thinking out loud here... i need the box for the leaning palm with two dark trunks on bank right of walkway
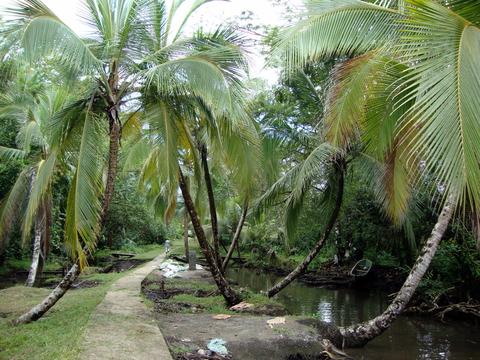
[131,92,255,305]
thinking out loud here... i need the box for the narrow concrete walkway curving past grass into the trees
[79,256,172,360]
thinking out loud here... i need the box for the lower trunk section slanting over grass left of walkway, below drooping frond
[14,264,80,325]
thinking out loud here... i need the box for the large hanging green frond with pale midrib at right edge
[400,0,480,212]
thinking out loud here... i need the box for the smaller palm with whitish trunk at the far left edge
[0,71,55,286]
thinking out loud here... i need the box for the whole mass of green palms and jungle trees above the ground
[0,0,480,358]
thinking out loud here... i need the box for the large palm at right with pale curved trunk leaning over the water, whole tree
[280,0,480,346]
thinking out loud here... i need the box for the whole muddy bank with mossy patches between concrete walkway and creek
[142,270,344,360]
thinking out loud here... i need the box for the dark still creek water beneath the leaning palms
[228,269,480,360]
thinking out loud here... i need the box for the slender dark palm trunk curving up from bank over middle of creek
[267,164,345,297]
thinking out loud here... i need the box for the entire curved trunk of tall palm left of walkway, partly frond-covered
[14,110,120,324]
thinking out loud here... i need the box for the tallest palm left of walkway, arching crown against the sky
[9,0,251,319]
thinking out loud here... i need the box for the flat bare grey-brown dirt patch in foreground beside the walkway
[156,314,323,360]
